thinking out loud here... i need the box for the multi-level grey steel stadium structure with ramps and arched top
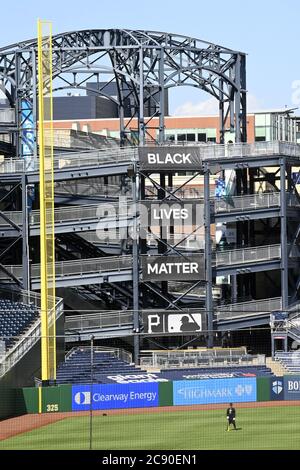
[0,30,300,361]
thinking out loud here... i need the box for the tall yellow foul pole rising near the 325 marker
[38,20,56,382]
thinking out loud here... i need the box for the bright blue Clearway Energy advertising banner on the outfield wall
[72,383,159,411]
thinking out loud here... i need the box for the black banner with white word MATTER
[141,254,205,281]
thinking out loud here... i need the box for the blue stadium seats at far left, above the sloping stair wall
[0,299,39,349]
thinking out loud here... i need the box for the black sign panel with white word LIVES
[139,199,204,227]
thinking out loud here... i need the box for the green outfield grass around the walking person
[0,406,300,450]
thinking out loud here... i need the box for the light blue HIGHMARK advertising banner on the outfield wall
[173,378,256,405]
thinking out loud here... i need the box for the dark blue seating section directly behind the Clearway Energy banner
[56,348,146,384]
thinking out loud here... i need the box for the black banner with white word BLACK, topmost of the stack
[139,146,203,172]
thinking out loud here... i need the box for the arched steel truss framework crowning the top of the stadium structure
[0,29,246,156]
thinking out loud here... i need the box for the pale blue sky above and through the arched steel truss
[0,0,300,115]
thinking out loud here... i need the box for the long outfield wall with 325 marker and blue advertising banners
[0,375,300,417]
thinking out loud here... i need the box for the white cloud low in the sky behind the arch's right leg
[174,93,263,116]
